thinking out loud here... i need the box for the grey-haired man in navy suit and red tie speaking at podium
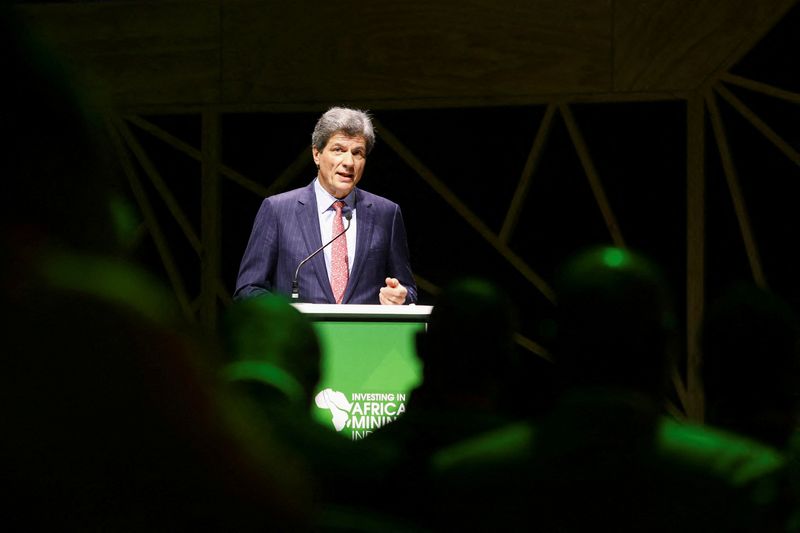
[234,107,417,305]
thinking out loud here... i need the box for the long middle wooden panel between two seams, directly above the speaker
[223,0,611,105]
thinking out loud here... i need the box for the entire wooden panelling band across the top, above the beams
[15,0,795,110]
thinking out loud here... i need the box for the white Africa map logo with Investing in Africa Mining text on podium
[314,389,406,440]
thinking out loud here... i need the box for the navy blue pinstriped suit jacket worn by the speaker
[234,181,417,304]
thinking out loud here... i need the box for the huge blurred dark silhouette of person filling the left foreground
[0,8,307,531]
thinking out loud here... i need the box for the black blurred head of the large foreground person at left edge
[0,6,125,258]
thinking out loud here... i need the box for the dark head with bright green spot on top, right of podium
[556,247,674,394]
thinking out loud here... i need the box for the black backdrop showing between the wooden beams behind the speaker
[128,3,800,354]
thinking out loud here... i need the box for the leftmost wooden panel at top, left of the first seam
[19,0,221,107]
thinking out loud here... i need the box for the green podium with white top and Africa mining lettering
[293,304,432,440]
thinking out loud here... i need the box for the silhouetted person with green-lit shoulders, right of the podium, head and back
[432,247,785,531]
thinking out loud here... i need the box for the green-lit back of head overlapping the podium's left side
[223,294,321,406]
